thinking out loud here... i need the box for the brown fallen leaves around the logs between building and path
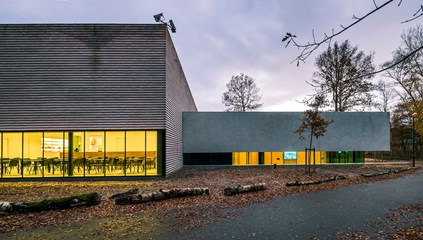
[0,165,420,238]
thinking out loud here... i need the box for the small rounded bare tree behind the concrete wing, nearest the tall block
[222,73,263,112]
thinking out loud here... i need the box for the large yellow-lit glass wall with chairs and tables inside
[0,131,162,178]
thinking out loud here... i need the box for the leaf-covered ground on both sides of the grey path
[0,164,423,239]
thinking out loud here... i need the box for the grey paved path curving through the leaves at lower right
[168,173,423,239]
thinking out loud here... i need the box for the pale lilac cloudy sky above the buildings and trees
[0,0,423,111]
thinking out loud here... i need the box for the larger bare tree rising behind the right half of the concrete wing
[310,40,374,112]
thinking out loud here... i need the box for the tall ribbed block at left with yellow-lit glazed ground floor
[0,24,197,178]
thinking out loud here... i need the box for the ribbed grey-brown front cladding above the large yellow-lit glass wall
[0,24,168,131]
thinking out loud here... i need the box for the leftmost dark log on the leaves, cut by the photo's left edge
[0,192,101,214]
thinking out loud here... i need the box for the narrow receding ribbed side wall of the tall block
[166,31,197,174]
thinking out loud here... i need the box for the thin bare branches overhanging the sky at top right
[282,0,423,75]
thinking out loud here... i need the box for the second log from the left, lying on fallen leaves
[114,188,210,205]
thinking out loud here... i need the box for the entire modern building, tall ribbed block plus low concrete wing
[0,24,390,178]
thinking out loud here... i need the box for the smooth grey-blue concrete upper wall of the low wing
[183,112,390,153]
